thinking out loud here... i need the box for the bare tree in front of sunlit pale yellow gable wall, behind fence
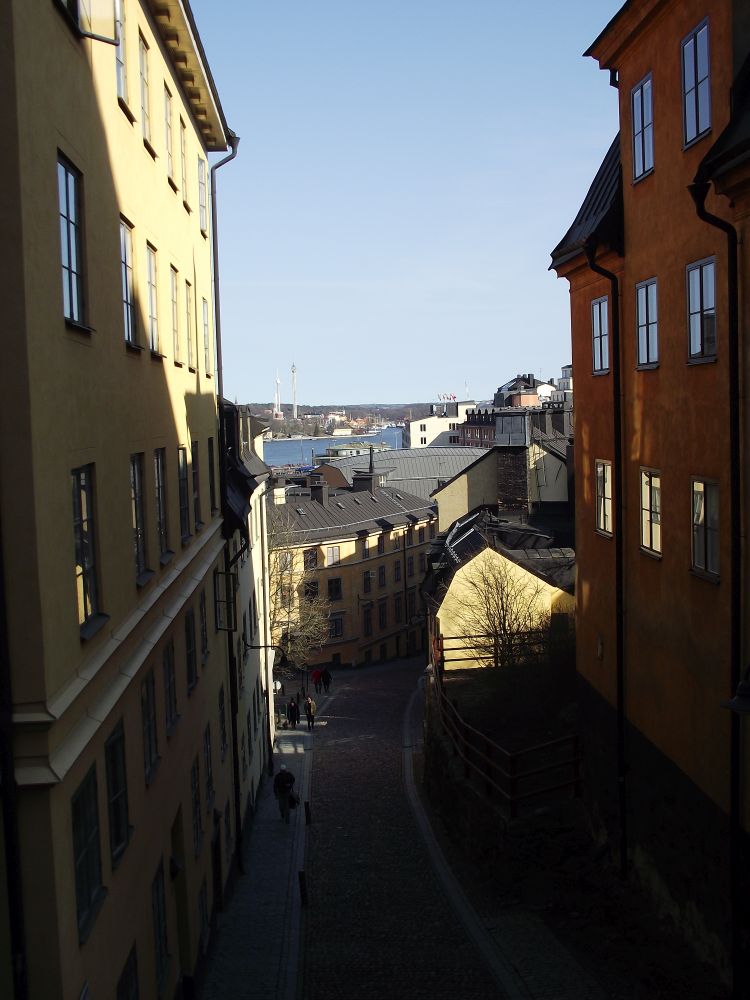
[446,549,550,666]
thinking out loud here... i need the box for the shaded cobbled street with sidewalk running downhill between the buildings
[200,659,608,1000]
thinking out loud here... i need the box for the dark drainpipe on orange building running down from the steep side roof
[584,240,628,879]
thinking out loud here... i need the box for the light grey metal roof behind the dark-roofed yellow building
[320,445,486,500]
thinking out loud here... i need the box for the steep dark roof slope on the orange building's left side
[550,132,623,270]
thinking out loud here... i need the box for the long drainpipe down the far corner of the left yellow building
[210,129,245,874]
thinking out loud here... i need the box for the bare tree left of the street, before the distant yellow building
[268,504,331,675]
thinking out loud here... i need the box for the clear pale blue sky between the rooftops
[191,0,621,404]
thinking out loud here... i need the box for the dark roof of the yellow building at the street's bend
[273,486,437,544]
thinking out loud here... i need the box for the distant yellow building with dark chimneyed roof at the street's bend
[272,469,437,666]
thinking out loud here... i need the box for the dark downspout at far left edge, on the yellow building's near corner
[0,531,29,1000]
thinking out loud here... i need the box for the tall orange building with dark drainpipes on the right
[552,0,750,984]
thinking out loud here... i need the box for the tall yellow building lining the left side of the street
[0,0,242,1000]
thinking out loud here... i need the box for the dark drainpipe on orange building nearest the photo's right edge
[688,181,746,998]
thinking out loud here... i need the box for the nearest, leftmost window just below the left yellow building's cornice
[71,765,104,940]
